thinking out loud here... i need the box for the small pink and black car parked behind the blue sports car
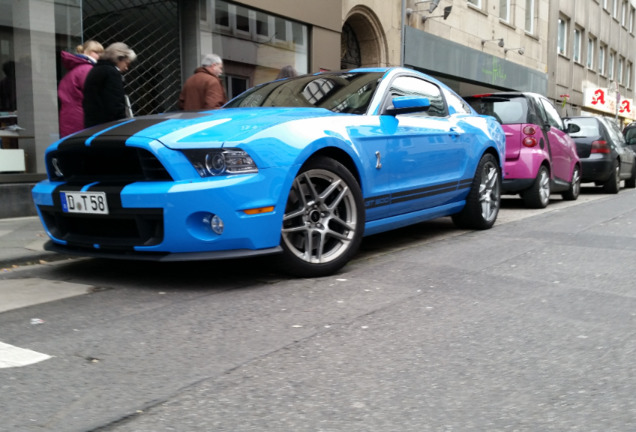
[464,92,581,208]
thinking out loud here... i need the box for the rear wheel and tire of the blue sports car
[452,154,501,230]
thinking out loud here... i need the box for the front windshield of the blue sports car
[224,72,383,114]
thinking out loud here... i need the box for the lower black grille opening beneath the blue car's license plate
[39,206,164,250]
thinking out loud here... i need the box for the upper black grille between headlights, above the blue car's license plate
[47,146,172,183]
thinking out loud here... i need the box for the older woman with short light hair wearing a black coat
[83,42,137,127]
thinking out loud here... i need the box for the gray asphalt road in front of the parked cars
[0,186,636,432]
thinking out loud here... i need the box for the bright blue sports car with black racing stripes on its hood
[33,68,505,277]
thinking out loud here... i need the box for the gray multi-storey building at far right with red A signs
[548,0,636,124]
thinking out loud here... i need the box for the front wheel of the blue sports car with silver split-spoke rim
[280,157,365,277]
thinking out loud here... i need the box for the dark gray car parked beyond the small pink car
[563,116,636,193]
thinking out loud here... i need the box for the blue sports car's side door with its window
[358,75,469,216]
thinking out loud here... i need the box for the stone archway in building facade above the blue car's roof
[340,6,388,69]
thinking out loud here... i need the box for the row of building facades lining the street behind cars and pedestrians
[0,0,636,217]
